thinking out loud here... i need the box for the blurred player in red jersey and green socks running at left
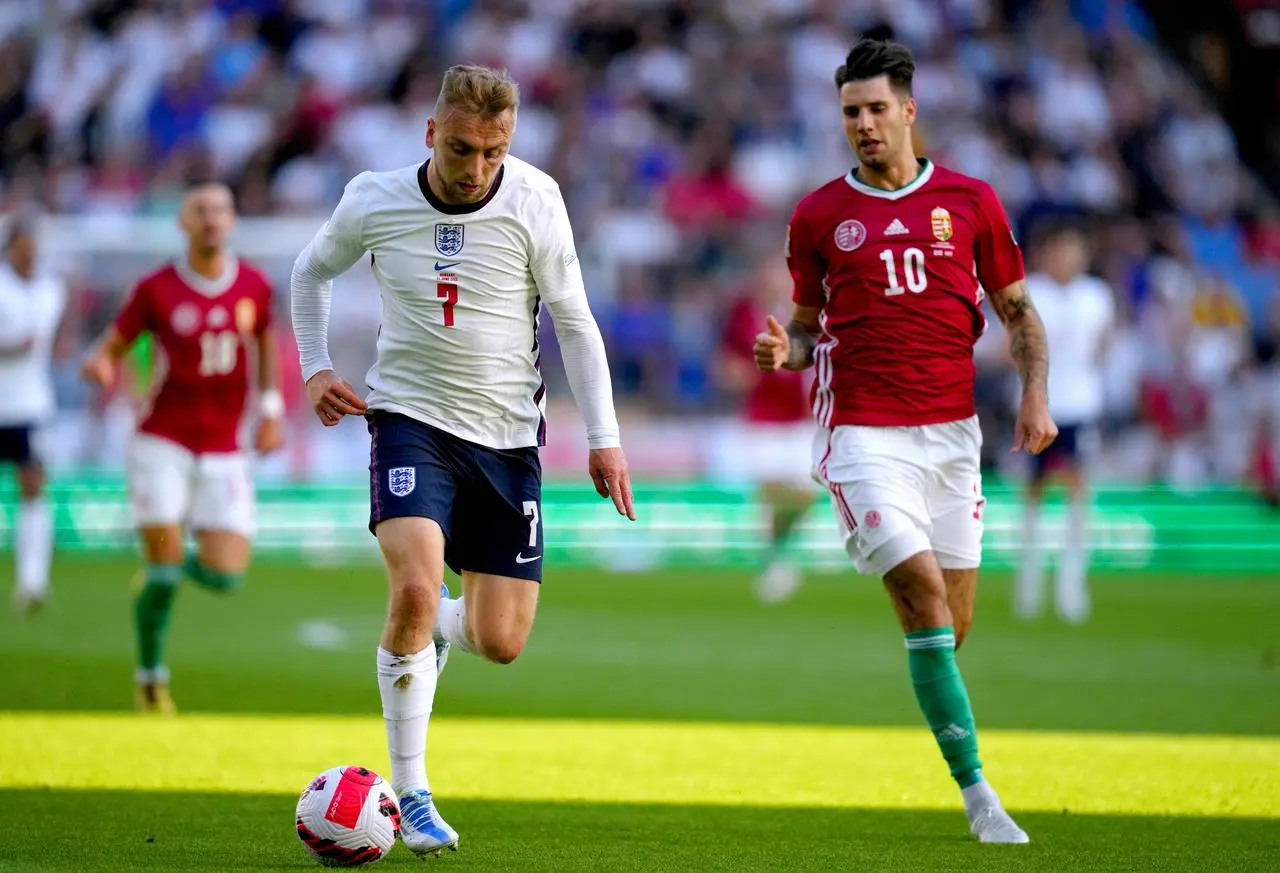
[83,182,284,712]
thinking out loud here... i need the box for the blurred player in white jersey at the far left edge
[0,220,67,613]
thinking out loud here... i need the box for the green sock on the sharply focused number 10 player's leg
[906,627,982,789]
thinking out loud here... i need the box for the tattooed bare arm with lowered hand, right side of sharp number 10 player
[991,279,1057,454]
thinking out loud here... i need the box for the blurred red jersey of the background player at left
[115,261,271,453]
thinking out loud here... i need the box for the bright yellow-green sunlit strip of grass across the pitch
[0,713,1280,818]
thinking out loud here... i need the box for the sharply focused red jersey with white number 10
[787,160,1024,428]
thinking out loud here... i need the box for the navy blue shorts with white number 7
[365,410,543,582]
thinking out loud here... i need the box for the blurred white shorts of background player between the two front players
[708,421,814,488]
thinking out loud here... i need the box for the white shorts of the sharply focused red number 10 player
[813,416,987,576]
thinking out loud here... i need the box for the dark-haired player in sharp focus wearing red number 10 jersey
[755,38,1057,842]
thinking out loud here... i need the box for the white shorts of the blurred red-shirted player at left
[128,434,255,536]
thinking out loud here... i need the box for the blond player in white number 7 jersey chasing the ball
[292,67,635,854]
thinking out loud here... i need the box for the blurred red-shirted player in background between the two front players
[710,257,815,603]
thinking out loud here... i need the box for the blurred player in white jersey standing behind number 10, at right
[1014,223,1115,623]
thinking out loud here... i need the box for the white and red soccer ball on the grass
[297,767,399,867]
